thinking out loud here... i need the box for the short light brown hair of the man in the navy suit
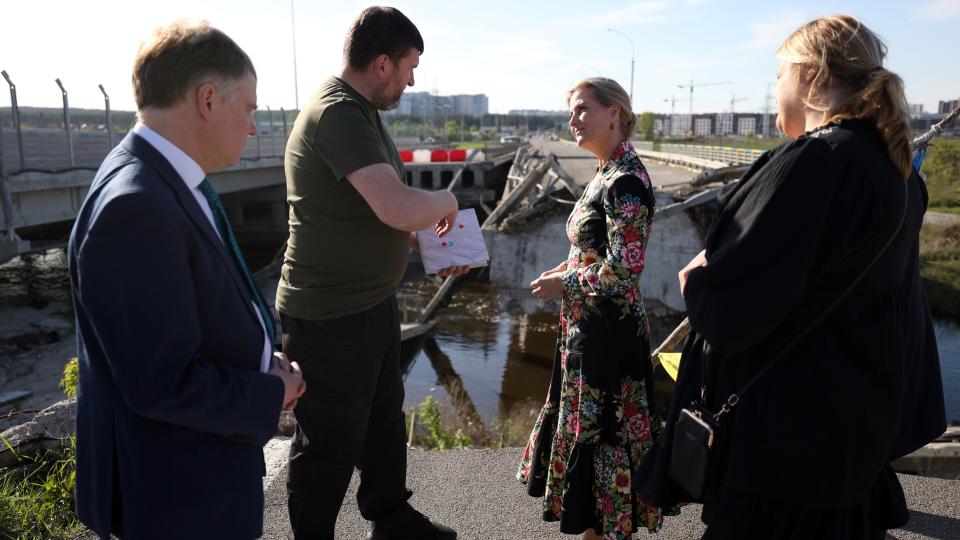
[133,19,257,110]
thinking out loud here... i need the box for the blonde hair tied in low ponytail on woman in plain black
[777,15,912,179]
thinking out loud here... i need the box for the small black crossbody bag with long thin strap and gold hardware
[669,178,910,503]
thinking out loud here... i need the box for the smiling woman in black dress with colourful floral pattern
[517,78,662,539]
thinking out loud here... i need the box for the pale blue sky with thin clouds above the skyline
[0,0,960,113]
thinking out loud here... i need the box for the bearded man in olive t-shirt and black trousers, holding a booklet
[277,7,467,540]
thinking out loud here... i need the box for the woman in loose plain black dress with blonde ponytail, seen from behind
[638,16,946,540]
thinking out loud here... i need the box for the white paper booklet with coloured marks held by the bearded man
[417,208,490,274]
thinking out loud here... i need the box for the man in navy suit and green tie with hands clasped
[68,21,304,539]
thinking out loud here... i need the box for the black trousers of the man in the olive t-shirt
[280,296,412,539]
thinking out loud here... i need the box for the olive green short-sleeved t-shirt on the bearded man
[277,77,409,320]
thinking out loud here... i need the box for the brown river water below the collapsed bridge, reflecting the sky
[401,283,960,438]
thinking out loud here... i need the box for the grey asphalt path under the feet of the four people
[263,441,960,540]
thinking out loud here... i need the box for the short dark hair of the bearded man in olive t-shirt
[343,6,423,69]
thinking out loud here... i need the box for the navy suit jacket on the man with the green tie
[68,133,283,539]
